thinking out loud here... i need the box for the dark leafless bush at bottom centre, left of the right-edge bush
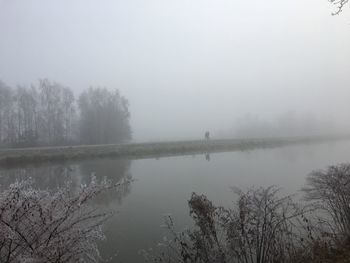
[144,187,307,263]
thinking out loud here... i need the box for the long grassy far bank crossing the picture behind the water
[0,135,350,165]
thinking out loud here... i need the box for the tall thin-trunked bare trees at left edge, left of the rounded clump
[0,79,75,147]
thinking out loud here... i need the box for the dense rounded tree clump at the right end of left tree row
[79,88,131,144]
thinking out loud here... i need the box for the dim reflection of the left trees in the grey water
[0,159,132,205]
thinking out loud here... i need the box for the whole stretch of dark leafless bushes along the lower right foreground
[143,164,350,263]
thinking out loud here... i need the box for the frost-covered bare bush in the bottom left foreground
[0,178,126,262]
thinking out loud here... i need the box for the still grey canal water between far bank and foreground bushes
[0,142,350,262]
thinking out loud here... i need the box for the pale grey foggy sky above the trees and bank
[0,0,350,140]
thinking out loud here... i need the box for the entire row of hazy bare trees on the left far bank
[0,79,131,147]
